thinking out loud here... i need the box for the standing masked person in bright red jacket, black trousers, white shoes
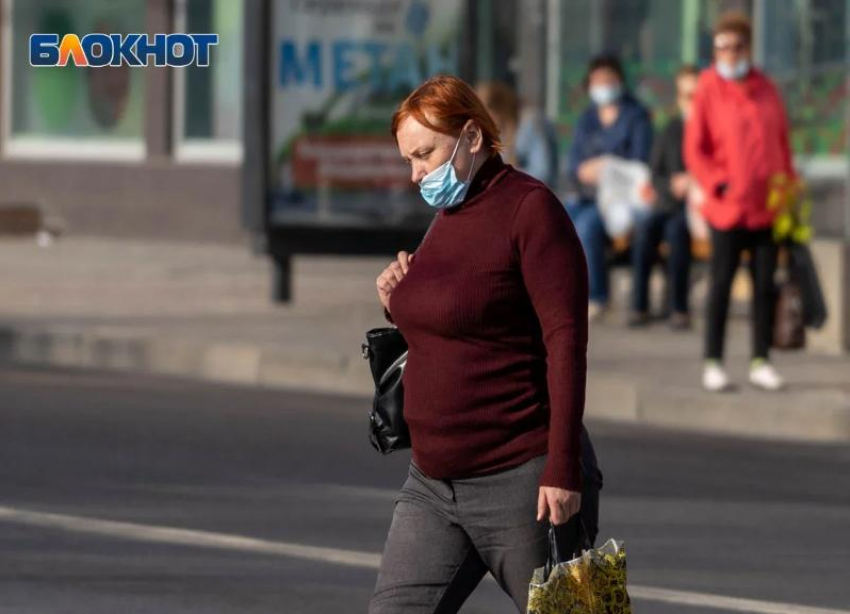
[684,14,794,392]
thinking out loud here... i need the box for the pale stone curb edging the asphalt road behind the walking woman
[0,326,850,443]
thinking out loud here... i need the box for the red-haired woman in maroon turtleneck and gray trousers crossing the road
[369,77,588,614]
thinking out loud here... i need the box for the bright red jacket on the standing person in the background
[684,67,794,230]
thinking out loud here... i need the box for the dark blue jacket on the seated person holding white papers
[567,93,652,201]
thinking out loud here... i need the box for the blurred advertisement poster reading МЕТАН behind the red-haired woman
[270,0,463,228]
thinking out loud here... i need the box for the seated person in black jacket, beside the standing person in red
[629,66,699,330]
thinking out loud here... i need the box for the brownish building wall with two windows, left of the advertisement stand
[0,0,244,242]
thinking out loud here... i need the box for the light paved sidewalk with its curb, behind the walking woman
[0,237,850,442]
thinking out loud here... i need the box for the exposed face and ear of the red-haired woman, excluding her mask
[396,116,482,184]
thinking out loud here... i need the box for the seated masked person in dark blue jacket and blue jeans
[567,54,652,320]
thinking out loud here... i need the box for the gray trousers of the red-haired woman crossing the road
[369,455,578,614]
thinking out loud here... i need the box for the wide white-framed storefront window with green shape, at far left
[4,0,147,158]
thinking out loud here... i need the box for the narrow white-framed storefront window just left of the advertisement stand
[176,0,244,162]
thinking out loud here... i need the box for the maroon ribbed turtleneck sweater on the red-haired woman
[390,156,588,490]
